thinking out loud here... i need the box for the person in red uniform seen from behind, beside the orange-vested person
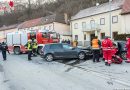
[102,36,113,66]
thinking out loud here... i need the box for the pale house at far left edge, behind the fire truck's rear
[0,24,18,42]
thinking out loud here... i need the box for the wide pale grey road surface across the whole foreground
[0,55,130,90]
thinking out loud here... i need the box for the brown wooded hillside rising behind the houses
[0,0,109,26]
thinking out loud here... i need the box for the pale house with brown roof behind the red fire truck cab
[41,14,72,41]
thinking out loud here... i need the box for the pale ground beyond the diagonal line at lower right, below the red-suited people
[73,61,130,86]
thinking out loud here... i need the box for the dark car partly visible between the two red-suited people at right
[114,41,127,60]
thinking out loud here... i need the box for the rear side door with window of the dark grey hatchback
[50,44,64,58]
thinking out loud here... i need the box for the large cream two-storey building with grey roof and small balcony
[71,0,130,46]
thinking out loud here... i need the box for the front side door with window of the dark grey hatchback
[63,44,77,58]
